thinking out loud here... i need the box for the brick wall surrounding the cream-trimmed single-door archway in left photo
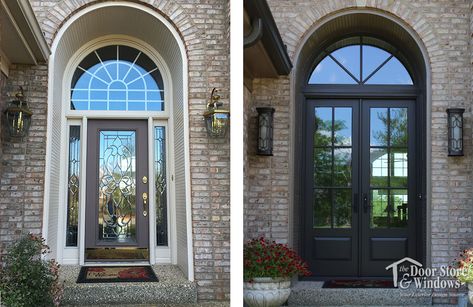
[0,0,230,300]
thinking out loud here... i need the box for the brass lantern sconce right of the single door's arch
[204,88,230,138]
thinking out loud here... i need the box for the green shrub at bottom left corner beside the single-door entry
[0,234,62,307]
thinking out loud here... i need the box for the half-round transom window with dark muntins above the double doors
[308,36,414,85]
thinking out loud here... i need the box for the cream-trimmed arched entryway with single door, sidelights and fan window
[43,1,193,280]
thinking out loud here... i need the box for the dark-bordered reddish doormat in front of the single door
[77,266,158,283]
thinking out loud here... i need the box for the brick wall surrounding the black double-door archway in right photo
[245,0,473,302]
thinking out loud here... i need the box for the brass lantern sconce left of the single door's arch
[5,86,33,138]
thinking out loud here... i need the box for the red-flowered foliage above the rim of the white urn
[243,237,311,281]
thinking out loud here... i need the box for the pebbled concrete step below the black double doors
[288,281,432,306]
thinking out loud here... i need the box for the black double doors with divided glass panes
[303,99,417,278]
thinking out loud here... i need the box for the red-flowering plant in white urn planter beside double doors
[243,237,311,307]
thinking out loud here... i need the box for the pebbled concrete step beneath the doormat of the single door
[60,265,197,306]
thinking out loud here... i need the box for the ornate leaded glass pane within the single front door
[98,130,136,243]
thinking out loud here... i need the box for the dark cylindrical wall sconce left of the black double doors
[256,107,274,156]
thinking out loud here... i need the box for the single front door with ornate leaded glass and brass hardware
[85,120,149,261]
